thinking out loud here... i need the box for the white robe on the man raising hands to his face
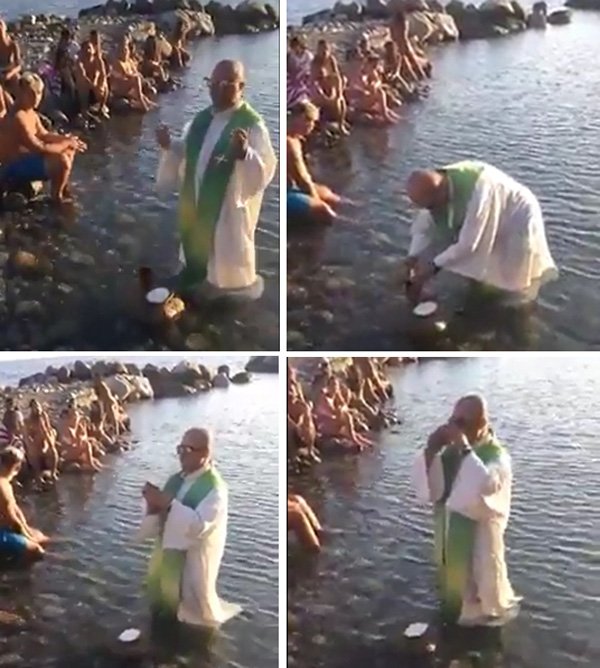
[411,449,521,626]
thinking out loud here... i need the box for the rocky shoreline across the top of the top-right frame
[288,0,576,48]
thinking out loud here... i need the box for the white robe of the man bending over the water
[409,164,558,299]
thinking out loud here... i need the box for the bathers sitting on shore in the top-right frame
[287,11,431,223]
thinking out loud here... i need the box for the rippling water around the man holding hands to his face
[288,358,600,668]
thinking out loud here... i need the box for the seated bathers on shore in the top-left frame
[0,19,190,202]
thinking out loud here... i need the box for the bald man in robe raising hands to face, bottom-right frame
[411,395,520,626]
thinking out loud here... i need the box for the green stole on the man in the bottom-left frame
[146,466,225,616]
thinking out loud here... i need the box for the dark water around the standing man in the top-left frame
[0,21,279,350]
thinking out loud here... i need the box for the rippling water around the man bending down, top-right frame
[288,3,600,350]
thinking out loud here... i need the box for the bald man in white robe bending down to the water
[405,161,558,304]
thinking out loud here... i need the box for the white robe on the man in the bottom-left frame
[138,468,241,627]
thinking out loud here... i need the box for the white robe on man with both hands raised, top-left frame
[157,103,277,290]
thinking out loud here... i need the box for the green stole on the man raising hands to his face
[434,434,505,622]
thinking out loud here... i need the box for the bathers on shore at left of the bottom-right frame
[287,357,394,550]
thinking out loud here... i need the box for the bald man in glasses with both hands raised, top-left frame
[157,60,277,299]
